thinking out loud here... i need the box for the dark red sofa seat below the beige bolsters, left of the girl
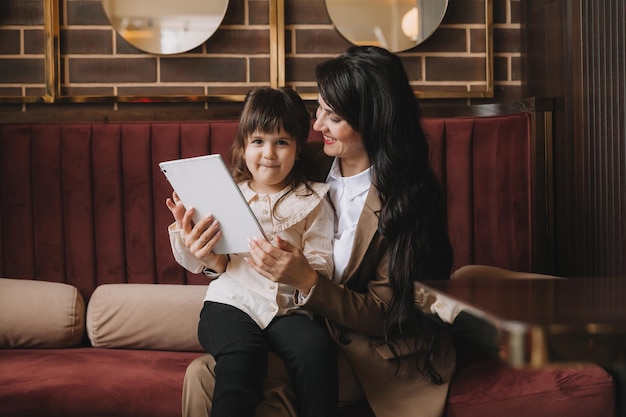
[0,347,202,417]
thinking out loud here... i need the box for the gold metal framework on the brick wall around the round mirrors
[7,0,494,103]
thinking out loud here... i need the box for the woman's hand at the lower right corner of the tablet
[246,237,318,295]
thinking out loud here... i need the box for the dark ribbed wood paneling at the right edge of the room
[522,0,626,276]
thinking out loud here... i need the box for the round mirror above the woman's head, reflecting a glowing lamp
[326,0,448,52]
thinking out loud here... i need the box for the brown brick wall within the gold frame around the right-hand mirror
[285,0,498,94]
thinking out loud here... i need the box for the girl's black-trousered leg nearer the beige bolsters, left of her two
[198,302,268,417]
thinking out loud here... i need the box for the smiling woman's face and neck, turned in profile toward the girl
[313,96,370,177]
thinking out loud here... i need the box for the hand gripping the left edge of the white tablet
[180,207,228,273]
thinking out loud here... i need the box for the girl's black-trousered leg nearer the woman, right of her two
[265,314,339,417]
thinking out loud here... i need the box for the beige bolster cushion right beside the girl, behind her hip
[87,284,207,351]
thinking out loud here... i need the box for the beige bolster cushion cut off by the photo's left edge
[0,278,85,348]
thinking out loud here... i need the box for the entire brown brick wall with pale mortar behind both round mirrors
[0,0,523,110]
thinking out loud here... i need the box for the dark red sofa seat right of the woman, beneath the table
[445,359,616,417]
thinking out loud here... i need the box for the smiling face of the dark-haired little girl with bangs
[244,129,297,194]
